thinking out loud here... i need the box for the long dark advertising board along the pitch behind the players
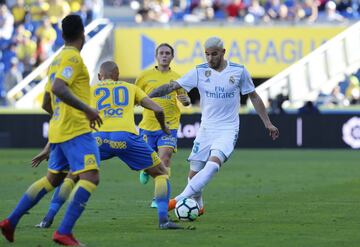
[0,114,360,149]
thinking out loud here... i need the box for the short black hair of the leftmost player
[61,15,84,42]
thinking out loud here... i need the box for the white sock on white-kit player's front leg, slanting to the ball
[175,161,220,202]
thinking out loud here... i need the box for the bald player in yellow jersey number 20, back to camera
[92,62,182,229]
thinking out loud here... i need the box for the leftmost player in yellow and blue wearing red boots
[0,15,102,246]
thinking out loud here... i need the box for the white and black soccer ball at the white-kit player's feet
[175,198,199,221]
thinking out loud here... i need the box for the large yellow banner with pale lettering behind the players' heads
[114,26,345,78]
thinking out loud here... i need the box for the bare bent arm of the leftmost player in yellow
[51,78,102,130]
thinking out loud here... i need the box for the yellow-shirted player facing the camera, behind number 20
[135,43,190,208]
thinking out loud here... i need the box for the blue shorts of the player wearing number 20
[93,131,161,171]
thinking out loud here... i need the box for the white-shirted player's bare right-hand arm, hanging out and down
[249,91,280,140]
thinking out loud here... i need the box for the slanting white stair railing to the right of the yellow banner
[256,21,360,107]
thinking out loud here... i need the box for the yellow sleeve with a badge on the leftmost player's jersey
[55,54,83,86]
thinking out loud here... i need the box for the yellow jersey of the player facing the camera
[135,67,186,131]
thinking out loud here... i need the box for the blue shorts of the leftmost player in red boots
[48,133,100,175]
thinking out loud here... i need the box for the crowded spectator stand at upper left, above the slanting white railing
[0,0,102,105]
